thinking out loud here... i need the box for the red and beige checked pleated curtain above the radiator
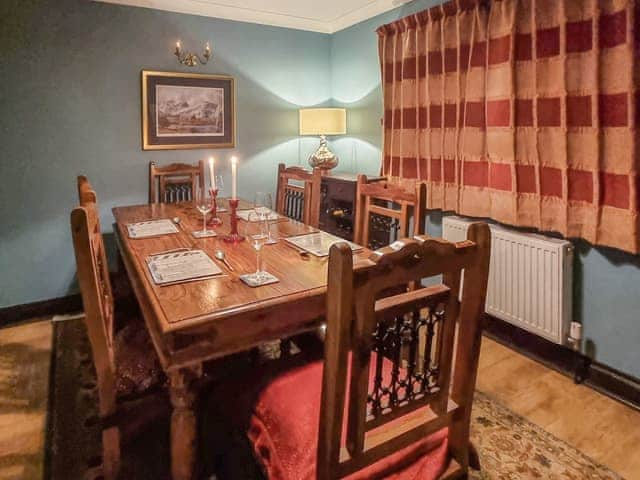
[378,0,640,253]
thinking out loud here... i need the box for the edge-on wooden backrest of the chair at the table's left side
[71,177,116,415]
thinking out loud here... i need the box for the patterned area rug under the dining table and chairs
[46,320,622,480]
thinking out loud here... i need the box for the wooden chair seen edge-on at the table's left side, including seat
[71,183,169,479]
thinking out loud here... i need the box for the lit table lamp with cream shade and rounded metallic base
[300,108,347,170]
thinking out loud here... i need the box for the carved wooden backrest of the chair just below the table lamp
[276,163,322,228]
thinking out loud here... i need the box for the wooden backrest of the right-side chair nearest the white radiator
[354,175,427,248]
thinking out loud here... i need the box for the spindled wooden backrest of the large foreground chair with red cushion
[317,223,491,479]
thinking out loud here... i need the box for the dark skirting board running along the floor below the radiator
[484,316,640,410]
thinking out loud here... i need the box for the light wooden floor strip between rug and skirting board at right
[477,337,640,480]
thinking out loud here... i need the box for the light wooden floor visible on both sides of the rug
[0,322,640,480]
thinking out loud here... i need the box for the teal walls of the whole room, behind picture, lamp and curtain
[0,0,640,377]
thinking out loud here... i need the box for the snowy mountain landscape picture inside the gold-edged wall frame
[156,85,224,137]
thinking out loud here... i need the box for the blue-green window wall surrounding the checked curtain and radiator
[331,0,640,377]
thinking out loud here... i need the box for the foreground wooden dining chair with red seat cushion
[234,223,491,480]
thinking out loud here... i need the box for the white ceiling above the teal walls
[96,0,408,33]
